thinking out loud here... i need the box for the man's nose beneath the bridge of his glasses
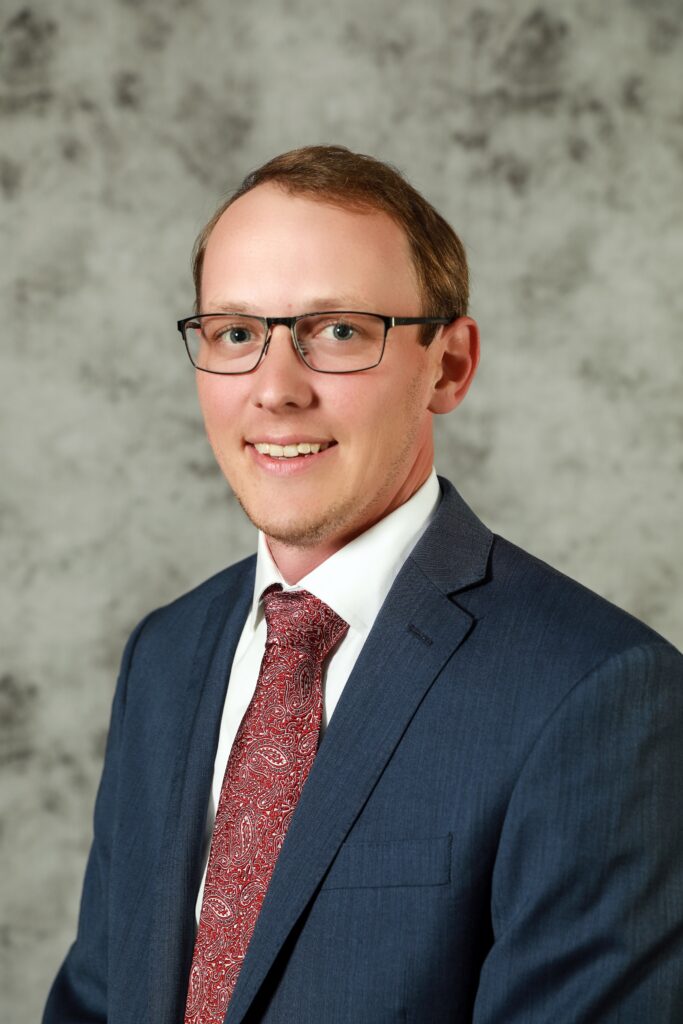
[252,324,314,412]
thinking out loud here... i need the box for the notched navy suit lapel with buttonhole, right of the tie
[226,481,492,1024]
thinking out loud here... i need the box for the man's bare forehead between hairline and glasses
[201,184,419,315]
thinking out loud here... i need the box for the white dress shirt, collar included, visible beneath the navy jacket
[196,469,440,923]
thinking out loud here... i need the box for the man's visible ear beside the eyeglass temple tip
[428,316,479,414]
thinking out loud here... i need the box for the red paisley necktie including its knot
[185,587,348,1024]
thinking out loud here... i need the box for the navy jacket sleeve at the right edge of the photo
[473,641,683,1024]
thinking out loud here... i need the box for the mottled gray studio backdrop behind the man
[0,0,683,1024]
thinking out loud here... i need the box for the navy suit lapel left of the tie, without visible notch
[146,559,254,1024]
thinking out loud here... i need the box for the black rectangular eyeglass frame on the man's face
[177,309,457,377]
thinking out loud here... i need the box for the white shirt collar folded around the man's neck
[249,469,441,632]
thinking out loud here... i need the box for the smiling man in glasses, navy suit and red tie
[45,146,683,1024]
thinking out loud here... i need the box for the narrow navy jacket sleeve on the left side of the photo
[43,620,151,1024]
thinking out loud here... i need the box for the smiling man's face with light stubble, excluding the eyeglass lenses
[197,184,450,557]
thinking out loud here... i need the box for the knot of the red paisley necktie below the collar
[262,585,348,664]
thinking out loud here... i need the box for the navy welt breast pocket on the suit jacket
[323,836,451,890]
